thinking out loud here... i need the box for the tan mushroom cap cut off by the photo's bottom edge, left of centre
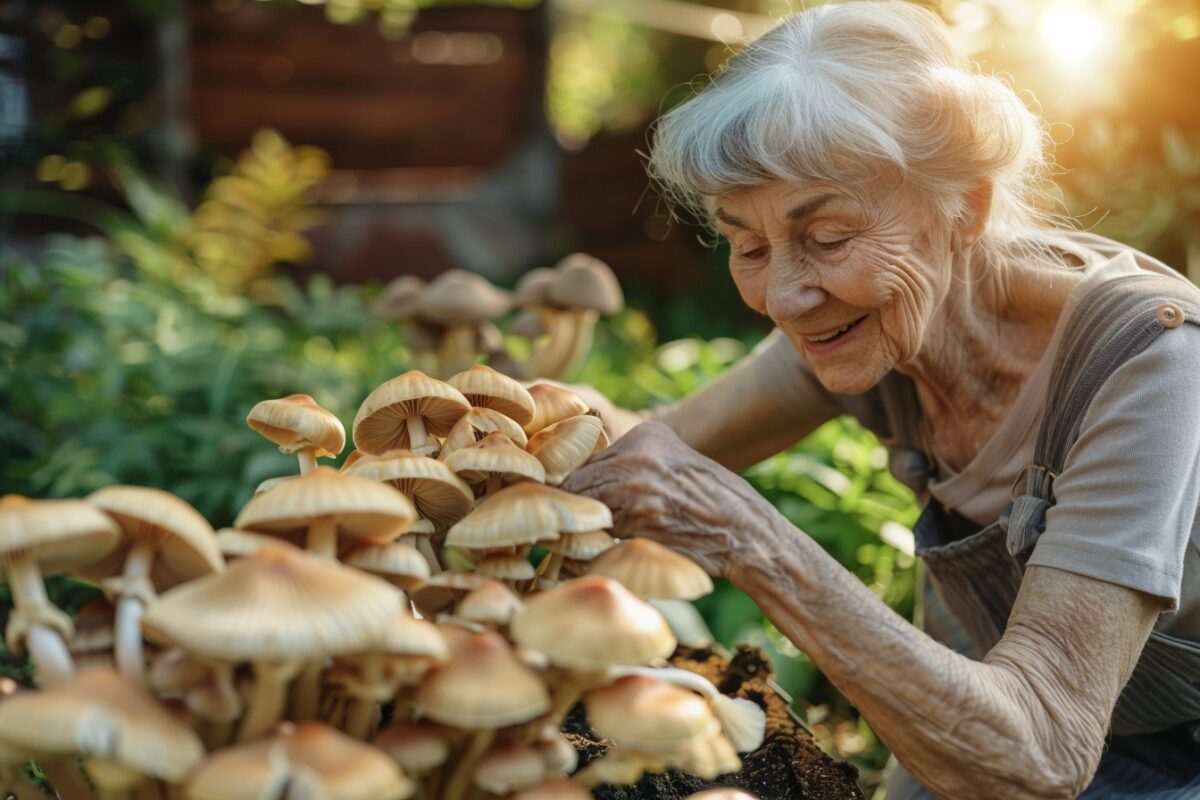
[185,722,416,800]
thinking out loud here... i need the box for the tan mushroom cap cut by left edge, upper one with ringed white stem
[0,494,121,575]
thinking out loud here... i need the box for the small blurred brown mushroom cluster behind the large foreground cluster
[374,253,625,380]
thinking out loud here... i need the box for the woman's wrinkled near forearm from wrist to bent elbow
[731,510,1103,799]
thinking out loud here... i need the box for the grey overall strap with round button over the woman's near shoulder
[1004,273,1200,557]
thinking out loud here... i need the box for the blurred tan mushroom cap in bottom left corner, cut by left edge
[0,669,204,783]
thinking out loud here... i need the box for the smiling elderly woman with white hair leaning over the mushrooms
[568,2,1200,800]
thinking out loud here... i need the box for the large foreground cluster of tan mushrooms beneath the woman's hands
[0,366,764,800]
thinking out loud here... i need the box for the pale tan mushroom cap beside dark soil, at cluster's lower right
[583,675,715,753]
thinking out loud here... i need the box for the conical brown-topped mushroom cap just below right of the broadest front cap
[415,625,550,730]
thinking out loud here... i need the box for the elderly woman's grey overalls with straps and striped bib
[880,273,1200,800]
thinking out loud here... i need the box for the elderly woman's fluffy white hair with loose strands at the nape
[648,1,1068,268]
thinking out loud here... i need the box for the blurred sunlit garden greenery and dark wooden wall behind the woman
[0,0,1200,796]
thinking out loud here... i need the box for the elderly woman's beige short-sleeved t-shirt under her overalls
[755,234,1200,642]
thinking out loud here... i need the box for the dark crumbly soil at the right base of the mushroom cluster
[564,646,863,800]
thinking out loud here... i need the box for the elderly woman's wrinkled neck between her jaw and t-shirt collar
[898,248,1078,469]
